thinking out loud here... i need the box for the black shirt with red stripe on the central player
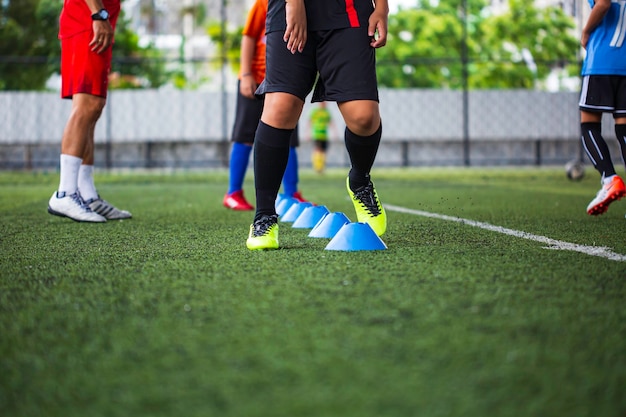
[265,0,374,33]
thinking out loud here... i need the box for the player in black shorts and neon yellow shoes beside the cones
[246,0,389,250]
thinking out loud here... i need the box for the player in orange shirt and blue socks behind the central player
[223,0,306,210]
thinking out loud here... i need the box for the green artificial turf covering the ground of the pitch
[0,168,626,417]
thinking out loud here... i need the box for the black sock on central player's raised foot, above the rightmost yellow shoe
[345,123,383,191]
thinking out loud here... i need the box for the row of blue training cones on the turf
[276,195,387,251]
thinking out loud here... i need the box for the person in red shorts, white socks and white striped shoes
[48,0,131,223]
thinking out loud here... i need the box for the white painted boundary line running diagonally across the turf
[385,204,626,262]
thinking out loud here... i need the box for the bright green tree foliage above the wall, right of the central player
[377,0,578,89]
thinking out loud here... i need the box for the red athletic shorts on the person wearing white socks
[61,31,113,98]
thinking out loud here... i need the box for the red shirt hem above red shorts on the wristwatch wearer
[59,0,121,39]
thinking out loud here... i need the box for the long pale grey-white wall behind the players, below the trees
[0,90,613,144]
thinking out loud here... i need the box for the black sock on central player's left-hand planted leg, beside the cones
[254,121,293,220]
